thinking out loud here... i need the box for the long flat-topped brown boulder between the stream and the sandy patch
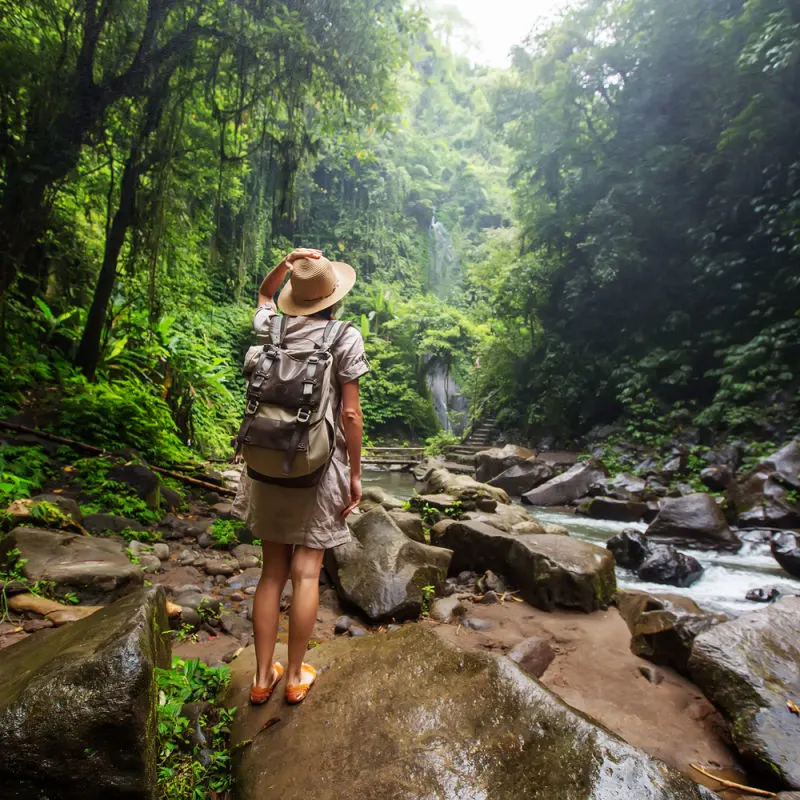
[431,522,616,611]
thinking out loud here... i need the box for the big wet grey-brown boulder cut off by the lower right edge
[689,597,800,789]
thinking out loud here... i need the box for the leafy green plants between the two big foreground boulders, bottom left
[156,658,235,800]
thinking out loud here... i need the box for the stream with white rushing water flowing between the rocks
[364,471,800,615]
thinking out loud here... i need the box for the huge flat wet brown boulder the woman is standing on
[227,625,714,800]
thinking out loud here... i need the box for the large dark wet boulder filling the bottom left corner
[0,588,170,800]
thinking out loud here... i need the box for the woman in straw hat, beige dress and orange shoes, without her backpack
[249,248,369,704]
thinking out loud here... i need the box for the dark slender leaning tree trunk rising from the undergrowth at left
[75,147,140,378]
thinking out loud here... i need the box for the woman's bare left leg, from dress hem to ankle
[253,542,292,686]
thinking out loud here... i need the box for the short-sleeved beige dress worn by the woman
[234,304,369,550]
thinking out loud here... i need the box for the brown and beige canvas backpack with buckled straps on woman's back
[237,315,350,487]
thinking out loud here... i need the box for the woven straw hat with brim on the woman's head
[278,256,356,317]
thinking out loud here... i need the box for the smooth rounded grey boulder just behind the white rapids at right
[647,492,742,550]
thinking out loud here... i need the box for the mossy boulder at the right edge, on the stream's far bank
[728,439,800,528]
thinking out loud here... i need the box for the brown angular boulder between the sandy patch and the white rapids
[614,590,726,675]
